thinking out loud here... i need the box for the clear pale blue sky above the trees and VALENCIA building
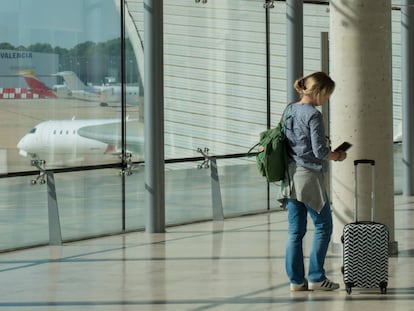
[0,0,120,48]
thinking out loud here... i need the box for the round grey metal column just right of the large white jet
[144,0,165,233]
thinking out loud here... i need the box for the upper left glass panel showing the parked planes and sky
[0,0,121,172]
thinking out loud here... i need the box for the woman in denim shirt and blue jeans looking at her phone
[285,72,346,291]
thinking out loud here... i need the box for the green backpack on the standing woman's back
[248,105,288,182]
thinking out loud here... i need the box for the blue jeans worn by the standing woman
[285,199,332,284]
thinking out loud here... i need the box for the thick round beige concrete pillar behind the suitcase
[329,0,397,253]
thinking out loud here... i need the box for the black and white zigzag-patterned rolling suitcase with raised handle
[342,160,388,294]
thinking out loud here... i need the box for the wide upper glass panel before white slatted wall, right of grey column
[164,0,266,159]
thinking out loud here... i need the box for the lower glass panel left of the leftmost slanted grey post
[0,176,49,251]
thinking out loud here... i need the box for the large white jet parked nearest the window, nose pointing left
[17,119,144,166]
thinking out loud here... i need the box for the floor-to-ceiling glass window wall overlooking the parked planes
[0,0,402,250]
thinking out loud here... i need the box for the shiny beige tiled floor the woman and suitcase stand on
[0,196,414,311]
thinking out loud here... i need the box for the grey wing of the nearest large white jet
[78,120,144,157]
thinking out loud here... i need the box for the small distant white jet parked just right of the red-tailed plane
[56,71,139,106]
